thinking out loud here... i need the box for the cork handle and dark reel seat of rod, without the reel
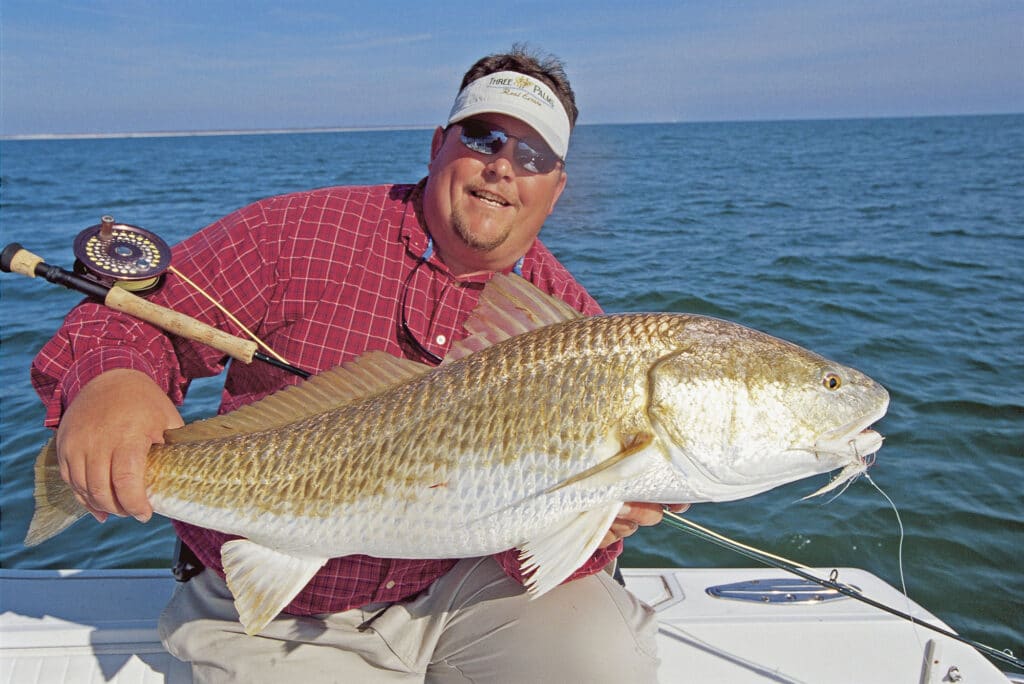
[0,243,257,364]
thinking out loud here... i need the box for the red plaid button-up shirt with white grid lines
[32,180,622,614]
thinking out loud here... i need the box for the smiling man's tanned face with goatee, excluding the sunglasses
[423,114,565,274]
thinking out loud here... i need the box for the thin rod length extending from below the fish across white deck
[663,510,1024,670]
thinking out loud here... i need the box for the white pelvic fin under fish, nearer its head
[519,502,623,598]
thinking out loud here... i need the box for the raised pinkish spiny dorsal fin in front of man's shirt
[443,273,583,364]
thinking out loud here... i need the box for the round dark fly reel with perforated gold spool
[74,216,171,294]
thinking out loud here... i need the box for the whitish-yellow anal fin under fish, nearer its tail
[220,540,328,636]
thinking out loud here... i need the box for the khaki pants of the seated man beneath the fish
[160,558,657,684]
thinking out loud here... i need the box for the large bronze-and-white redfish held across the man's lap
[26,275,889,634]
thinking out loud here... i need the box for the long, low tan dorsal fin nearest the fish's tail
[164,351,431,444]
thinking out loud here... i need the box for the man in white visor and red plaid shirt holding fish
[33,48,679,682]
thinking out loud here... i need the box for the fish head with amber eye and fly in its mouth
[648,316,889,501]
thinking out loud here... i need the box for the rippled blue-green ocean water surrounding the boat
[0,116,1024,654]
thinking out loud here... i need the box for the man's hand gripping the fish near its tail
[56,369,184,522]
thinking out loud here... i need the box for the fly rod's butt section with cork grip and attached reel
[0,216,311,379]
